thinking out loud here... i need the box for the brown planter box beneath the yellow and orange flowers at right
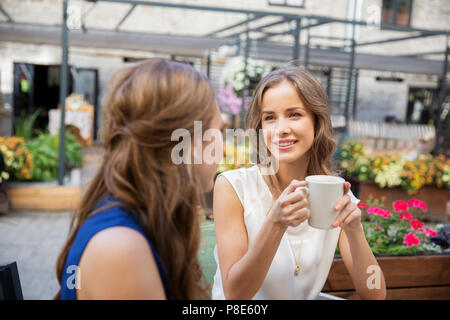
[348,179,450,217]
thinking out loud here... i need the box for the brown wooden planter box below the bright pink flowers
[322,254,450,300]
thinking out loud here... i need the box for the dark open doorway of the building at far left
[13,63,98,140]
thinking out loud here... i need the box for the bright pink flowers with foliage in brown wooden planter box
[323,198,450,299]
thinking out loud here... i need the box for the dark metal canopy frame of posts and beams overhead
[0,0,449,184]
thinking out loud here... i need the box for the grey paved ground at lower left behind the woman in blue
[0,147,102,299]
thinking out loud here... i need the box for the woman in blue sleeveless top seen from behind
[56,59,223,299]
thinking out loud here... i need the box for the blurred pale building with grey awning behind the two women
[0,0,450,154]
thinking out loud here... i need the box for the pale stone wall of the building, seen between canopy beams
[0,0,450,135]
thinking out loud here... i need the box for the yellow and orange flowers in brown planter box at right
[339,140,450,216]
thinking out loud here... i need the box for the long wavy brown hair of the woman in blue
[55,59,217,299]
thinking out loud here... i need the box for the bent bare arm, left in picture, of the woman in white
[214,176,307,299]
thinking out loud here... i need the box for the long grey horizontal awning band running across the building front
[0,23,444,75]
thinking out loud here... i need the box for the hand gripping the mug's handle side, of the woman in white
[268,179,309,228]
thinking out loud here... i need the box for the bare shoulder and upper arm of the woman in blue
[77,226,165,299]
